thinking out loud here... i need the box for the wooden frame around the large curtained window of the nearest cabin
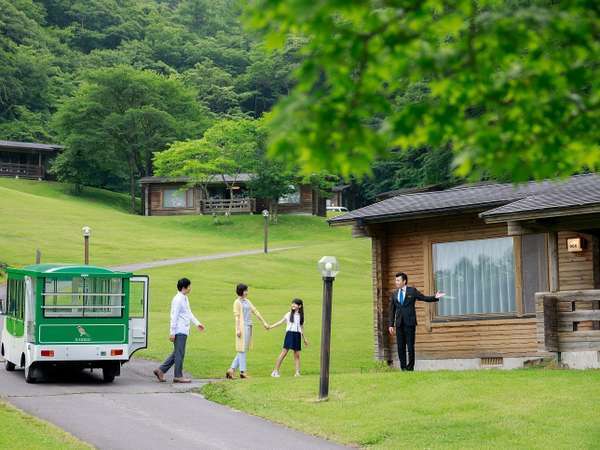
[423,233,535,331]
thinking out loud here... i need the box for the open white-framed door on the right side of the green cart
[129,275,149,357]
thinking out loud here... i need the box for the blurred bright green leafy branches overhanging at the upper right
[248,0,600,181]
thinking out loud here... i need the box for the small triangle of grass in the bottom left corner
[0,401,92,450]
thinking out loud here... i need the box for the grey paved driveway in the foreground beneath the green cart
[0,319,343,450]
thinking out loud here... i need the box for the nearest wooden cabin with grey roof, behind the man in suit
[330,174,600,370]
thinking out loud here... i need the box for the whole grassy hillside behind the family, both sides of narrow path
[0,179,374,377]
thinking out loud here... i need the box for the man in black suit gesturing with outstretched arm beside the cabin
[388,272,446,371]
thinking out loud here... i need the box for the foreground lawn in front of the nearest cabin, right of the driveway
[203,369,600,449]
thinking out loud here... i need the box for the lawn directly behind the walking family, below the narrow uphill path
[142,239,374,377]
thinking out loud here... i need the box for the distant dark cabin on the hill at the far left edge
[0,141,63,180]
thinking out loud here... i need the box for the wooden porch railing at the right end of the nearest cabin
[535,289,600,352]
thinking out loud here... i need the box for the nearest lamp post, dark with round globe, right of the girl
[319,256,339,400]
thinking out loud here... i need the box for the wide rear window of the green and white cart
[43,277,124,317]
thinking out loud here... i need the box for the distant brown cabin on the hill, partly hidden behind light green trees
[140,173,325,216]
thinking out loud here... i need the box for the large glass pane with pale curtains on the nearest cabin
[432,237,516,316]
